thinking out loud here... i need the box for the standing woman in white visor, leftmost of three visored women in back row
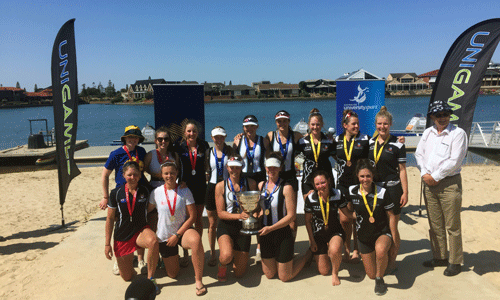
[205,126,233,267]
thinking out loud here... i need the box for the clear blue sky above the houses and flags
[0,0,500,91]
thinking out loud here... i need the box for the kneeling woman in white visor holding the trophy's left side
[215,155,257,281]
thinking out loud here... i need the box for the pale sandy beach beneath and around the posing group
[0,166,500,299]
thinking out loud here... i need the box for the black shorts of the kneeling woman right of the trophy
[260,225,295,263]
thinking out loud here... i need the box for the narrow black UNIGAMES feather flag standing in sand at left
[51,19,80,230]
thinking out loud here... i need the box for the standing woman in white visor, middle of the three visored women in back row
[233,115,269,183]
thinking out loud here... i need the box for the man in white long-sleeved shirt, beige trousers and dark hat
[415,100,468,276]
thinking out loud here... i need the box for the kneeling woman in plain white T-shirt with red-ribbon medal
[148,160,207,296]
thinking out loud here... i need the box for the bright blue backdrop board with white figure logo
[337,80,385,136]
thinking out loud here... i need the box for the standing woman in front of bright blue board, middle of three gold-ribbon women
[335,109,370,262]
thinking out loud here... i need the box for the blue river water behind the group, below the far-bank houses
[0,96,500,165]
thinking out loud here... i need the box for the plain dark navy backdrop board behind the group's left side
[153,84,205,140]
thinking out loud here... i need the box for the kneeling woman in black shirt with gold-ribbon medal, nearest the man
[349,158,397,295]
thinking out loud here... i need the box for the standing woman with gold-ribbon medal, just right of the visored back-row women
[297,108,337,199]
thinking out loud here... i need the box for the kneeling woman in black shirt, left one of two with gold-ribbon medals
[304,170,354,286]
